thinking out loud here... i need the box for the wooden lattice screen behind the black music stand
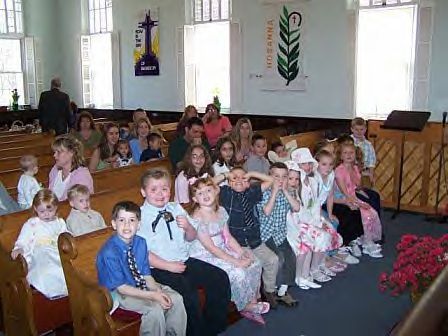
[369,121,448,214]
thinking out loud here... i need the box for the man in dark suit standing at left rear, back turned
[39,78,70,135]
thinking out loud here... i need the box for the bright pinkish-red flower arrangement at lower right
[379,234,448,296]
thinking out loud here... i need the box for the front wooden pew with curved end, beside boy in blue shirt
[58,228,140,336]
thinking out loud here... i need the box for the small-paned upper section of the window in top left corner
[0,0,23,34]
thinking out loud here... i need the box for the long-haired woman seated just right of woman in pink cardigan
[89,122,119,173]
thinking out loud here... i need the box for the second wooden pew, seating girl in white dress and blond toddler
[0,185,143,335]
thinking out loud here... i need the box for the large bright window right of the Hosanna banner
[355,0,417,119]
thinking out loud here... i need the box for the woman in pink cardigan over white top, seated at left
[48,135,94,201]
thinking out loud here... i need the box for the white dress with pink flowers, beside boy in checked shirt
[286,171,342,255]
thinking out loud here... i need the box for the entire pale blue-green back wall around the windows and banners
[41,0,448,120]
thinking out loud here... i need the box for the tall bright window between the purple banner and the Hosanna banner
[184,0,230,111]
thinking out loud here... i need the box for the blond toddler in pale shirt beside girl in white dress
[67,184,106,237]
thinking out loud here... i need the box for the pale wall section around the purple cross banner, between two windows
[113,0,185,111]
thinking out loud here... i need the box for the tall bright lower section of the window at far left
[0,39,24,106]
